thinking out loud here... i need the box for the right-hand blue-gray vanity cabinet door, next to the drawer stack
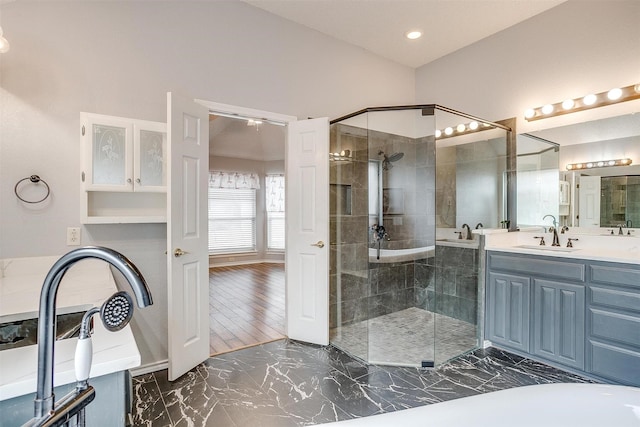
[532,279,585,370]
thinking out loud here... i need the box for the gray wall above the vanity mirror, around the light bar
[416,0,640,133]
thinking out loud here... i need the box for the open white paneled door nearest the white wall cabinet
[167,92,209,381]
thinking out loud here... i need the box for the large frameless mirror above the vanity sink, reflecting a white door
[518,113,640,228]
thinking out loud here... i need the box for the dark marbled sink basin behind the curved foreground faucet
[0,311,85,351]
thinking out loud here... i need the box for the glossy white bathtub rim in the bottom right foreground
[327,384,640,427]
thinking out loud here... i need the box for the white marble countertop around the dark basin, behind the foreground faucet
[0,257,140,400]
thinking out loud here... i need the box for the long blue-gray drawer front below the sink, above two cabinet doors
[489,253,585,282]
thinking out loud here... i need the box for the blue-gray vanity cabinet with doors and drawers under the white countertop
[485,251,640,386]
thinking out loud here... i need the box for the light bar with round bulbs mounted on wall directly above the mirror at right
[524,83,640,122]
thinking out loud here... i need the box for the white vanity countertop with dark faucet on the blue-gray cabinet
[485,231,640,264]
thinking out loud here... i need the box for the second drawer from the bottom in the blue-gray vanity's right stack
[589,308,640,350]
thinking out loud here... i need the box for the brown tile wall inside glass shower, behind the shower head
[330,125,435,328]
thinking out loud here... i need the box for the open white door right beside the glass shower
[285,118,329,345]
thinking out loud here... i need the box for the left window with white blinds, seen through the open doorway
[209,173,256,254]
